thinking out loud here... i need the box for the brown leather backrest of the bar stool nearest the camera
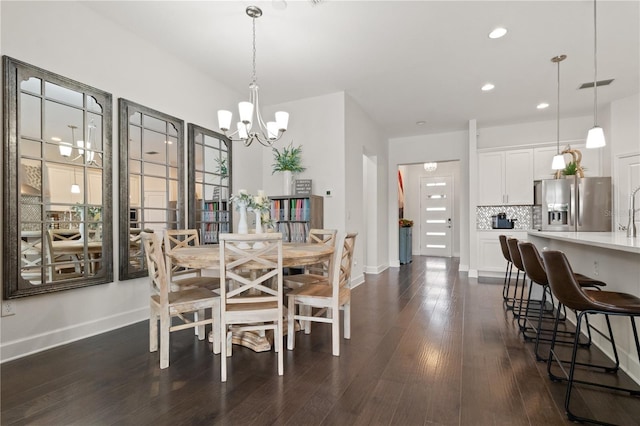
[541,250,594,311]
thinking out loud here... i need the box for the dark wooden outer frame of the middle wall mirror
[118,98,185,281]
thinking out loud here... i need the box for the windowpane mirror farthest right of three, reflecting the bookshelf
[187,123,233,244]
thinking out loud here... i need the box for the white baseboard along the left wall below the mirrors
[0,307,149,363]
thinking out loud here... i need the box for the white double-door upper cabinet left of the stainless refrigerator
[478,149,533,206]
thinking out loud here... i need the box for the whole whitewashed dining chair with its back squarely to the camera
[219,233,284,382]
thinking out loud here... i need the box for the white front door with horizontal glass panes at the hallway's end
[419,176,453,257]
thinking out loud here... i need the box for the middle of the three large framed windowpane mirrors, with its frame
[118,98,185,280]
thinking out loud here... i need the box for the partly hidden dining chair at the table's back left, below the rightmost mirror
[164,229,220,293]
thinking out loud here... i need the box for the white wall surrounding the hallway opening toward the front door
[387,131,469,269]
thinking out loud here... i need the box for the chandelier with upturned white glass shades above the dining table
[218,6,289,147]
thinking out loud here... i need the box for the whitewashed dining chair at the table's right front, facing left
[287,233,358,356]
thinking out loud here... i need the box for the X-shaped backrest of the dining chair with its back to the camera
[219,233,283,311]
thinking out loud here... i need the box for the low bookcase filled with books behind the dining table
[269,195,324,242]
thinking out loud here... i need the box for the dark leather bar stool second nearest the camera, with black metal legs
[518,241,606,361]
